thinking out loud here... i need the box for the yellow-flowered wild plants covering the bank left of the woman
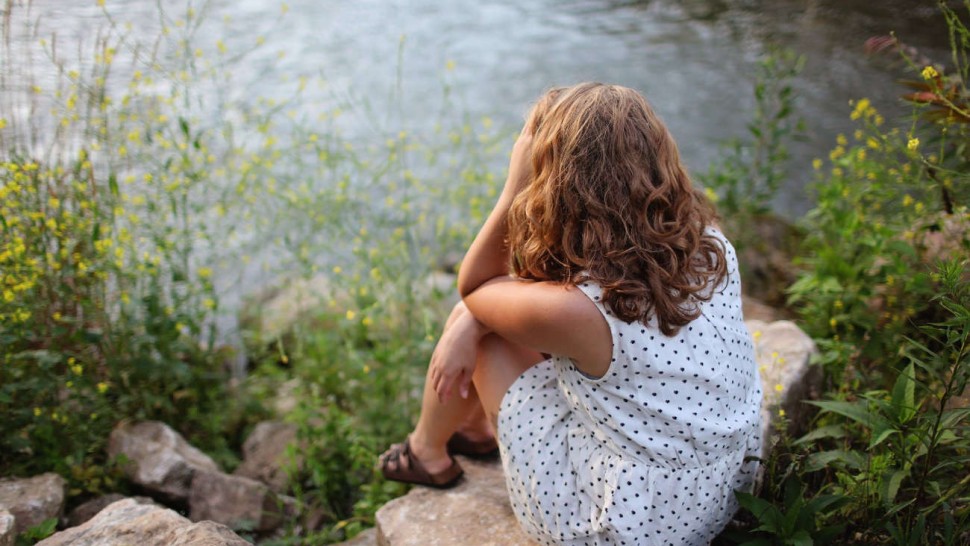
[7,3,502,542]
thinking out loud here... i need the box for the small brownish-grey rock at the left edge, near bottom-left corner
[0,472,66,535]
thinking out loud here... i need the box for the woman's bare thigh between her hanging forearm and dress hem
[474,334,545,430]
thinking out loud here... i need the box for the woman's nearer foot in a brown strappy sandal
[380,435,464,489]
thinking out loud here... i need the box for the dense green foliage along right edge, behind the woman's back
[728,3,970,544]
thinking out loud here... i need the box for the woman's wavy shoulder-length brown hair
[508,83,727,335]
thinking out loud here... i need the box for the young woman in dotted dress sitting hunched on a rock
[381,83,761,545]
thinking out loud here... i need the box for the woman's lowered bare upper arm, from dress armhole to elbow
[465,277,613,375]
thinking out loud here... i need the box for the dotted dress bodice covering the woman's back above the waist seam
[559,227,761,468]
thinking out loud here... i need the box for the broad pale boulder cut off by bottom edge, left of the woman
[38,499,249,546]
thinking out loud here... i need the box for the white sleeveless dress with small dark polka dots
[498,232,761,546]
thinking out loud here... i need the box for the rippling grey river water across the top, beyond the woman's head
[9,0,948,215]
